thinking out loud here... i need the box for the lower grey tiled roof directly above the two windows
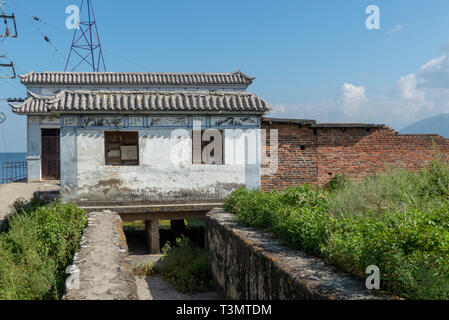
[13,91,271,114]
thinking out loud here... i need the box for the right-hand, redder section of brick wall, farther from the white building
[317,128,449,184]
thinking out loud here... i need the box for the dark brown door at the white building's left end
[42,129,61,180]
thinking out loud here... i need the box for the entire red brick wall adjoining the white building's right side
[262,122,449,190]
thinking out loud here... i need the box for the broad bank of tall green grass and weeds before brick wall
[224,159,449,299]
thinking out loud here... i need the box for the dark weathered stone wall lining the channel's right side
[206,209,384,300]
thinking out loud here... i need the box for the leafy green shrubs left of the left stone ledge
[0,200,87,300]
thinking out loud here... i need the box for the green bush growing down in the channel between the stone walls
[155,236,214,294]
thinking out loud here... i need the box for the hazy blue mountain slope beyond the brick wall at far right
[399,113,449,138]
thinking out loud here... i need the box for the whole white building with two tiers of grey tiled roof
[13,72,271,203]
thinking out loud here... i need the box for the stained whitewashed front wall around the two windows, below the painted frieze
[61,117,260,202]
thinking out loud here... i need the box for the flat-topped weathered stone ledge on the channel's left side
[63,211,137,300]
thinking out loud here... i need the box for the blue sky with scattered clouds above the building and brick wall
[0,0,449,152]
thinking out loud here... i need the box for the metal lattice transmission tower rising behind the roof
[64,0,106,72]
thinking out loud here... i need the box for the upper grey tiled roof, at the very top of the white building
[20,71,254,87]
